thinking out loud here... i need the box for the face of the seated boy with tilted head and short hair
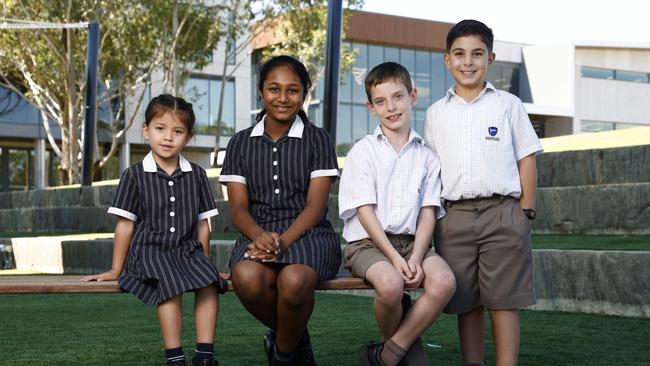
[368,80,417,134]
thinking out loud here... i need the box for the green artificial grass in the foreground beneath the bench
[0,293,650,366]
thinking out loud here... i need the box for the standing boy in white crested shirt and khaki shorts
[424,20,542,366]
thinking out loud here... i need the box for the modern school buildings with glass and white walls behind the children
[0,12,650,190]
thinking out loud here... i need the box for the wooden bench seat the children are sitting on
[0,275,372,294]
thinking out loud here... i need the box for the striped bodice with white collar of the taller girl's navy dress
[219,116,339,224]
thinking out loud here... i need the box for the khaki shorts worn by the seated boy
[343,233,436,280]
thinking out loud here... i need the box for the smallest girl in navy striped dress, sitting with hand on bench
[82,94,227,365]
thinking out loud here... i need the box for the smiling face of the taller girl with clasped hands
[260,65,304,124]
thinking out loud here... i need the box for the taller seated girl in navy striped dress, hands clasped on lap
[219,56,341,365]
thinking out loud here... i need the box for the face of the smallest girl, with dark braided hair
[142,112,192,165]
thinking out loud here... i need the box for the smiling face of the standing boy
[445,35,495,97]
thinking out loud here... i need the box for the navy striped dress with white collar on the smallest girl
[108,153,227,305]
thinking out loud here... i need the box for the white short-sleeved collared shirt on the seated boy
[339,126,440,242]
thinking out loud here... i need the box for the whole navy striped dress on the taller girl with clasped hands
[219,117,341,281]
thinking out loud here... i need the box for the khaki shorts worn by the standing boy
[435,197,536,314]
